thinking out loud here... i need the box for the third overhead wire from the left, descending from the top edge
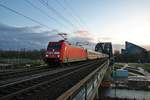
[38,0,77,29]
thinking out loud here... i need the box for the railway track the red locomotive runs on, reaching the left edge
[0,62,89,86]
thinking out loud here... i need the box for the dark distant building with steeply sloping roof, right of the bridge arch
[121,41,147,54]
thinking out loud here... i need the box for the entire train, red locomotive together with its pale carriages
[44,40,108,65]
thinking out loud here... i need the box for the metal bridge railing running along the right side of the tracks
[57,60,109,100]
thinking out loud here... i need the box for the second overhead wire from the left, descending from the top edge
[24,0,66,28]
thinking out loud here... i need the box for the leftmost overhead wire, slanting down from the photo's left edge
[0,4,52,29]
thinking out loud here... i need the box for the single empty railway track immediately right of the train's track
[0,59,102,100]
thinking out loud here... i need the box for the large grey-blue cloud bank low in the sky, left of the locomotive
[0,24,62,50]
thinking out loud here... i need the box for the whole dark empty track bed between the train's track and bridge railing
[0,61,106,100]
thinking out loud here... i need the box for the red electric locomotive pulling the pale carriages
[45,40,88,64]
